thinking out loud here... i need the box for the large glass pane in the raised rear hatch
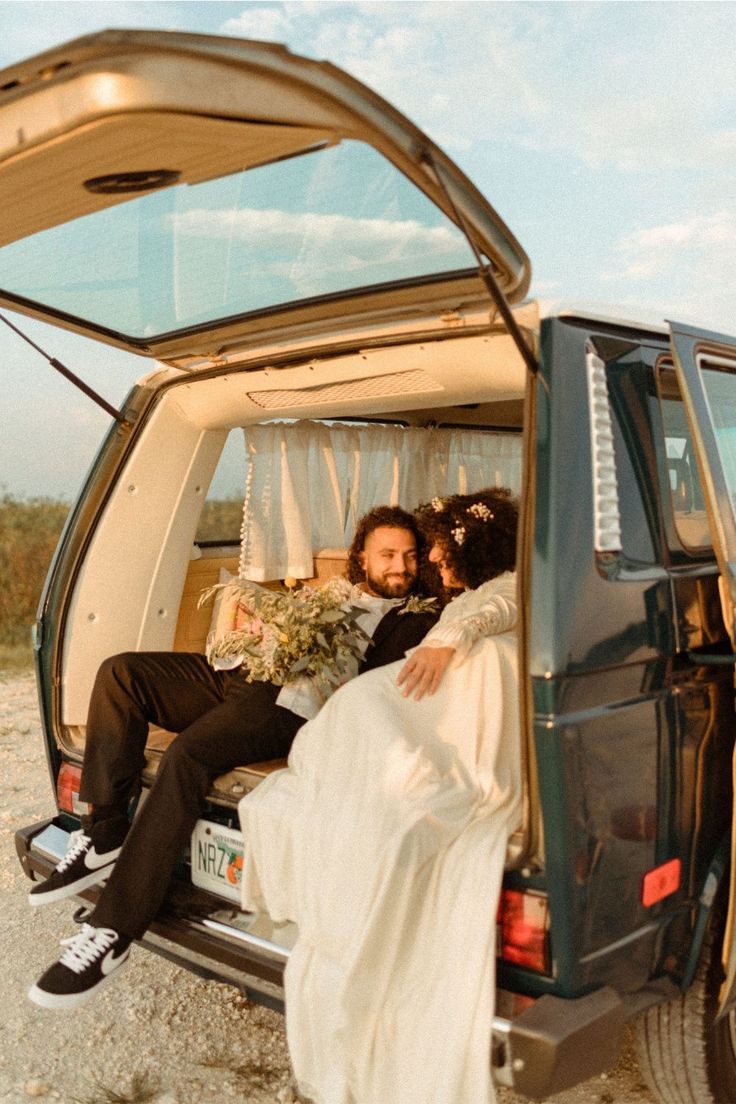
[0,141,474,339]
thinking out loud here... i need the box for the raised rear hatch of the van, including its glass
[0,31,531,360]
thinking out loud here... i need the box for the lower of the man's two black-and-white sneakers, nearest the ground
[28,924,132,1008]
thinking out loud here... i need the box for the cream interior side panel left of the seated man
[61,402,226,724]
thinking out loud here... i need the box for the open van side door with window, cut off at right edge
[670,322,736,1011]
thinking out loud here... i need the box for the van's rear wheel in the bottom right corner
[634,934,736,1104]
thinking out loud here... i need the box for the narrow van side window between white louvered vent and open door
[658,368,710,549]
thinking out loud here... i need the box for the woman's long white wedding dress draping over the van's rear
[239,573,521,1104]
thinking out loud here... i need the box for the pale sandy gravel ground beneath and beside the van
[0,675,653,1104]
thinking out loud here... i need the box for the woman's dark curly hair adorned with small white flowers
[415,487,519,588]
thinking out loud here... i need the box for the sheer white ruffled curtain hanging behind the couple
[239,422,521,582]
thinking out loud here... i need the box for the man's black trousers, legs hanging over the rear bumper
[79,651,305,938]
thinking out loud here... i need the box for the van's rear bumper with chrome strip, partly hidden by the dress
[15,819,625,1100]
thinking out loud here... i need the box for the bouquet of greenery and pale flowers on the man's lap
[199,576,367,696]
